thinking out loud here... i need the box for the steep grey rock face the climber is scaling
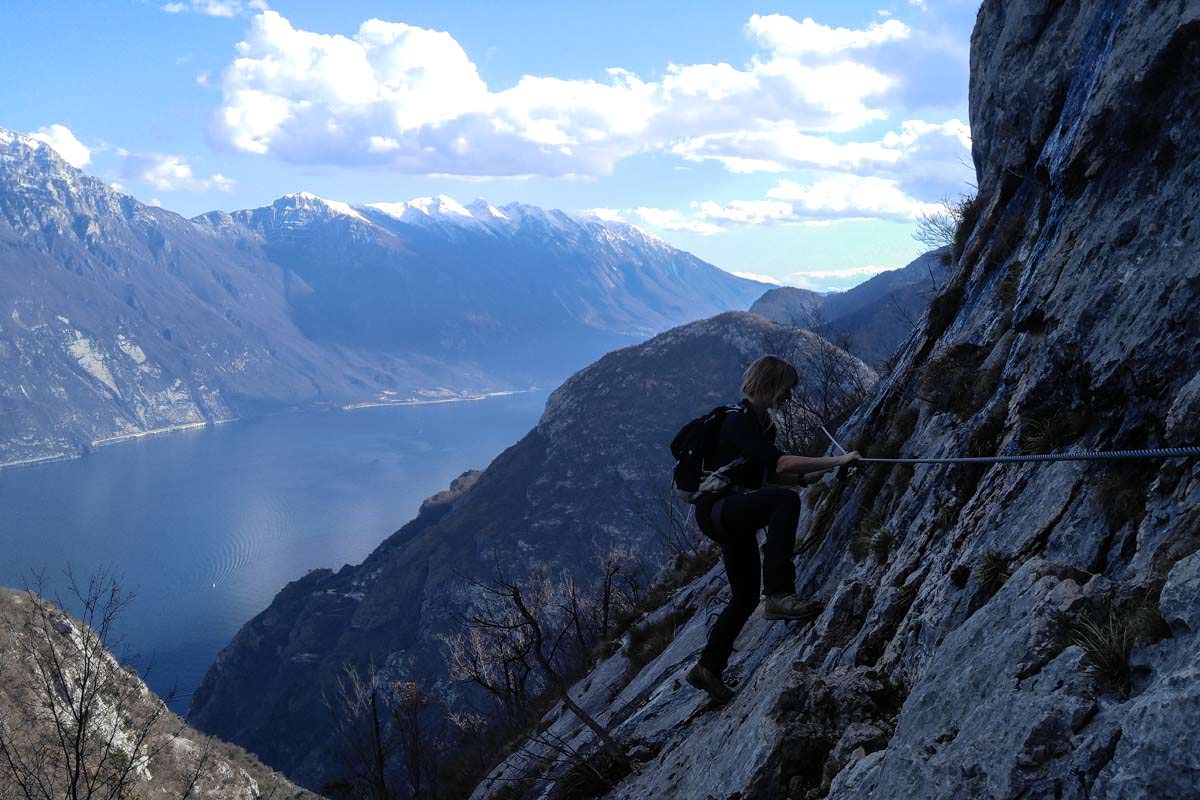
[475,0,1200,800]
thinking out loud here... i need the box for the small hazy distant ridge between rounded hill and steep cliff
[750,248,950,369]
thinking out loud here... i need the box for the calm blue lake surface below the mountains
[0,391,548,712]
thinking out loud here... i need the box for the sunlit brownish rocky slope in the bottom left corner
[0,588,317,800]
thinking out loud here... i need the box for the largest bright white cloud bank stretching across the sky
[215,11,908,176]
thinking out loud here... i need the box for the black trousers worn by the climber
[700,488,800,674]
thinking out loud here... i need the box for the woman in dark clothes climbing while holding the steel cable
[688,355,859,703]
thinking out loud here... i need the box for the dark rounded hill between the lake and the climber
[188,312,874,787]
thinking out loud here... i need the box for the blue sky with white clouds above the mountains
[0,0,978,290]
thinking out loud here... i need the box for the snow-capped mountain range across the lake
[0,130,763,465]
